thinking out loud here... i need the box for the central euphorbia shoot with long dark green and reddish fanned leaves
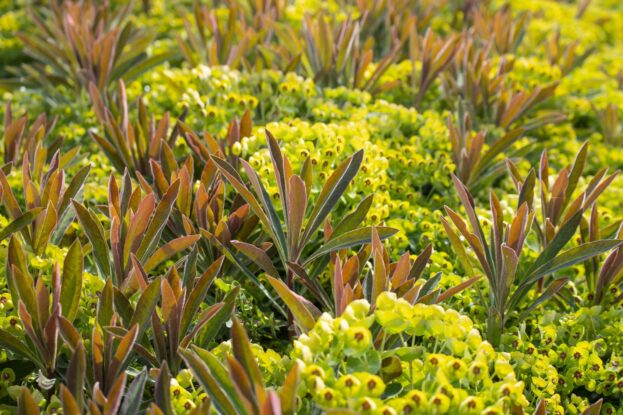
[212,131,396,330]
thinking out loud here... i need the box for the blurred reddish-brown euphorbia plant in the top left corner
[18,0,171,93]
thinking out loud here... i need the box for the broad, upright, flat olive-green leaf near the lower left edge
[60,239,84,321]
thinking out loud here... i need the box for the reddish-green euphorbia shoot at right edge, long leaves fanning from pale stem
[441,171,621,346]
